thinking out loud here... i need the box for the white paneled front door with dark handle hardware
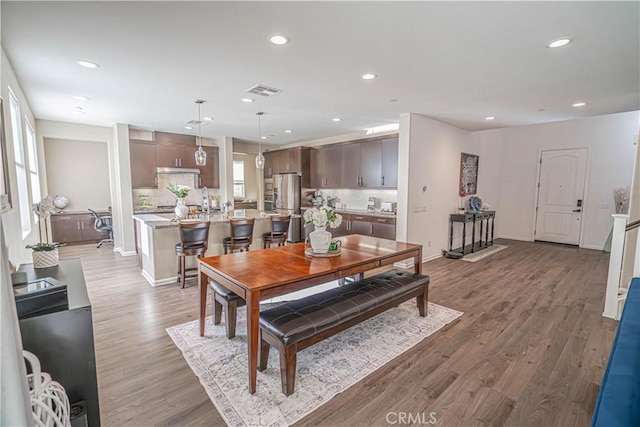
[535,148,587,245]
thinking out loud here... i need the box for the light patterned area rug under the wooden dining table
[167,300,462,426]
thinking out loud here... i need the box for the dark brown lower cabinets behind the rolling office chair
[51,212,109,244]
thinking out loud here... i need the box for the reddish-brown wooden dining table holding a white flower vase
[198,234,422,393]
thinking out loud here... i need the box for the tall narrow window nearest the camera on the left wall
[9,88,31,238]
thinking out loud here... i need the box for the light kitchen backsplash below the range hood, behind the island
[133,173,220,210]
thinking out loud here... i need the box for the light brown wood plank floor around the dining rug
[62,240,617,426]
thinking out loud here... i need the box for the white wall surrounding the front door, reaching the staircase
[472,111,640,249]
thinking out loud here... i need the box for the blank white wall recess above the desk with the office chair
[44,138,111,211]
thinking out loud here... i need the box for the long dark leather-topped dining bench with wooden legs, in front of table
[258,270,429,396]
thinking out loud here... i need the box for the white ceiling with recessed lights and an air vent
[1,1,640,145]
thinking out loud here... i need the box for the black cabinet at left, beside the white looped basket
[20,259,100,427]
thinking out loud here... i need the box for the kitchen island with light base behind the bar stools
[133,209,284,286]
